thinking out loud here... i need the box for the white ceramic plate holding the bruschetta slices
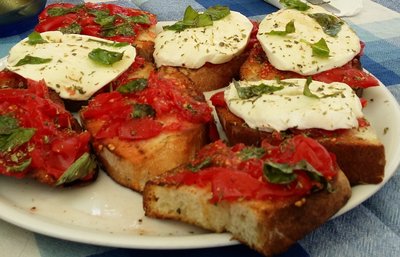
[0,56,400,249]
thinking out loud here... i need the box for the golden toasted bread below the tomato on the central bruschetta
[85,123,207,192]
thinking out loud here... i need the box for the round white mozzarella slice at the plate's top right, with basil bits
[257,6,361,75]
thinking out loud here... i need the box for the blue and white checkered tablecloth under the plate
[0,0,400,257]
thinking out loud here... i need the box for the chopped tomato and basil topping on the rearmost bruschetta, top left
[35,3,157,44]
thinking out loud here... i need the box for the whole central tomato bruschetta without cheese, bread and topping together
[80,71,211,192]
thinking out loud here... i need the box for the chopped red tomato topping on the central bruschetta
[82,72,211,140]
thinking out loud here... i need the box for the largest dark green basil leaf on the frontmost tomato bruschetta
[263,162,297,184]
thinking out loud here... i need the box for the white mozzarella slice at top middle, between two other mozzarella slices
[154,11,253,69]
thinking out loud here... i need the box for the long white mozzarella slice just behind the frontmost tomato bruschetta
[224,79,363,132]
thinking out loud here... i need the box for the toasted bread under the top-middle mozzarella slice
[159,52,248,92]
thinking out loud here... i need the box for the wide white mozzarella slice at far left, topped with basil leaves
[7,31,136,100]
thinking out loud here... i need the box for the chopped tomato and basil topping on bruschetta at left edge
[0,80,90,181]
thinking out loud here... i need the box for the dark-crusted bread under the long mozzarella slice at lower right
[216,107,386,185]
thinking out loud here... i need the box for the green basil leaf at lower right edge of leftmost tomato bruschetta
[56,153,96,186]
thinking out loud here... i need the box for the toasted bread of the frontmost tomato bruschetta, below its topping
[143,169,351,256]
